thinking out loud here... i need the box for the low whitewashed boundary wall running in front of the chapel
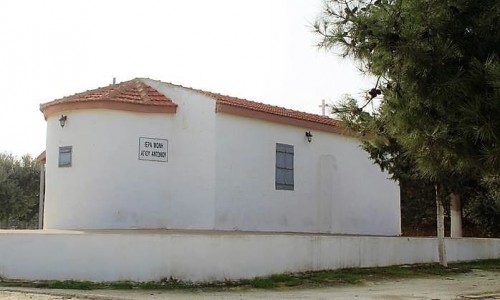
[0,230,500,281]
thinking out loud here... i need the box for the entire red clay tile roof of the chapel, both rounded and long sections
[40,78,345,134]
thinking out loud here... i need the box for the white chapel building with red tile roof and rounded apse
[40,79,401,236]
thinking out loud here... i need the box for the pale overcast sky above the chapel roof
[0,0,376,156]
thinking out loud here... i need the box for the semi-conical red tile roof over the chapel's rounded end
[40,79,177,115]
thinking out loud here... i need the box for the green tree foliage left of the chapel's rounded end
[0,153,40,228]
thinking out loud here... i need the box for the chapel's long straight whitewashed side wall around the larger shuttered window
[215,113,401,235]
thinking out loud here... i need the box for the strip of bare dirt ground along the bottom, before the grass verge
[0,271,500,300]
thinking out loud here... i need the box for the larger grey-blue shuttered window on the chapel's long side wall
[275,143,294,191]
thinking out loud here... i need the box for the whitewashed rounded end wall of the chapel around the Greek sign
[44,83,219,229]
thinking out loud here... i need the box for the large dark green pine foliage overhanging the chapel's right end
[316,0,500,189]
